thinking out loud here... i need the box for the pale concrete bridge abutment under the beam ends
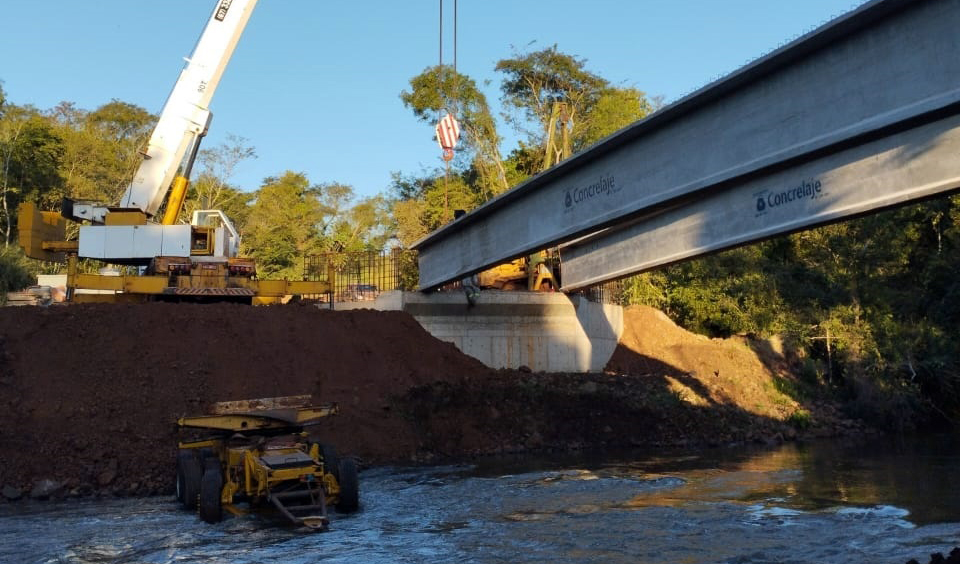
[336,290,623,372]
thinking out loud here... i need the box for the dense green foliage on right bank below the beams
[620,202,960,427]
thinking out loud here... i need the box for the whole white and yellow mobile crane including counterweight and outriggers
[18,0,330,304]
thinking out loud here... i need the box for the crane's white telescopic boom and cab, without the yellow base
[63,0,257,264]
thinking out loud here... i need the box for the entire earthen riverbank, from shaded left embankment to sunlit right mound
[0,303,866,502]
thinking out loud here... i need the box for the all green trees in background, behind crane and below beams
[0,46,960,426]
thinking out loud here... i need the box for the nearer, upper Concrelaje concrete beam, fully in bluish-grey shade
[414,0,960,289]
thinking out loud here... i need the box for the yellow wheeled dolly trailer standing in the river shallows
[177,396,360,530]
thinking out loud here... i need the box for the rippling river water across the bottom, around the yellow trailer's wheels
[0,436,960,564]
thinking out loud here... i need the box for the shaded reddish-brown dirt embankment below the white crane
[0,304,490,493]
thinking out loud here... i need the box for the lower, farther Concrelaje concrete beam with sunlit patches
[560,116,960,291]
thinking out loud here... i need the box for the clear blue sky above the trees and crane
[0,0,858,200]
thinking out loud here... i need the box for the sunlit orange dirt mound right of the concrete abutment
[606,306,860,442]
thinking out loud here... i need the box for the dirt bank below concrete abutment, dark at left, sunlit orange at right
[390,306,867,455]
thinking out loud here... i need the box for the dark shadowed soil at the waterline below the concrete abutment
[395,347,797,461]
